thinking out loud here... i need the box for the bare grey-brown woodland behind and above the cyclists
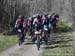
[0,0,75,32]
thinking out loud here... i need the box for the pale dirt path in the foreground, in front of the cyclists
[0,44,42,56]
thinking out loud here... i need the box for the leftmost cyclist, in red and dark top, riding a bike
[15,15,25,46]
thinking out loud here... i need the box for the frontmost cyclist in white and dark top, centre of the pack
[33,15,41,50]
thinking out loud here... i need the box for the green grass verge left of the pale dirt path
[0,35,18,51]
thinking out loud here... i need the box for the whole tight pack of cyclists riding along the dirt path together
[15,13,59,47]
